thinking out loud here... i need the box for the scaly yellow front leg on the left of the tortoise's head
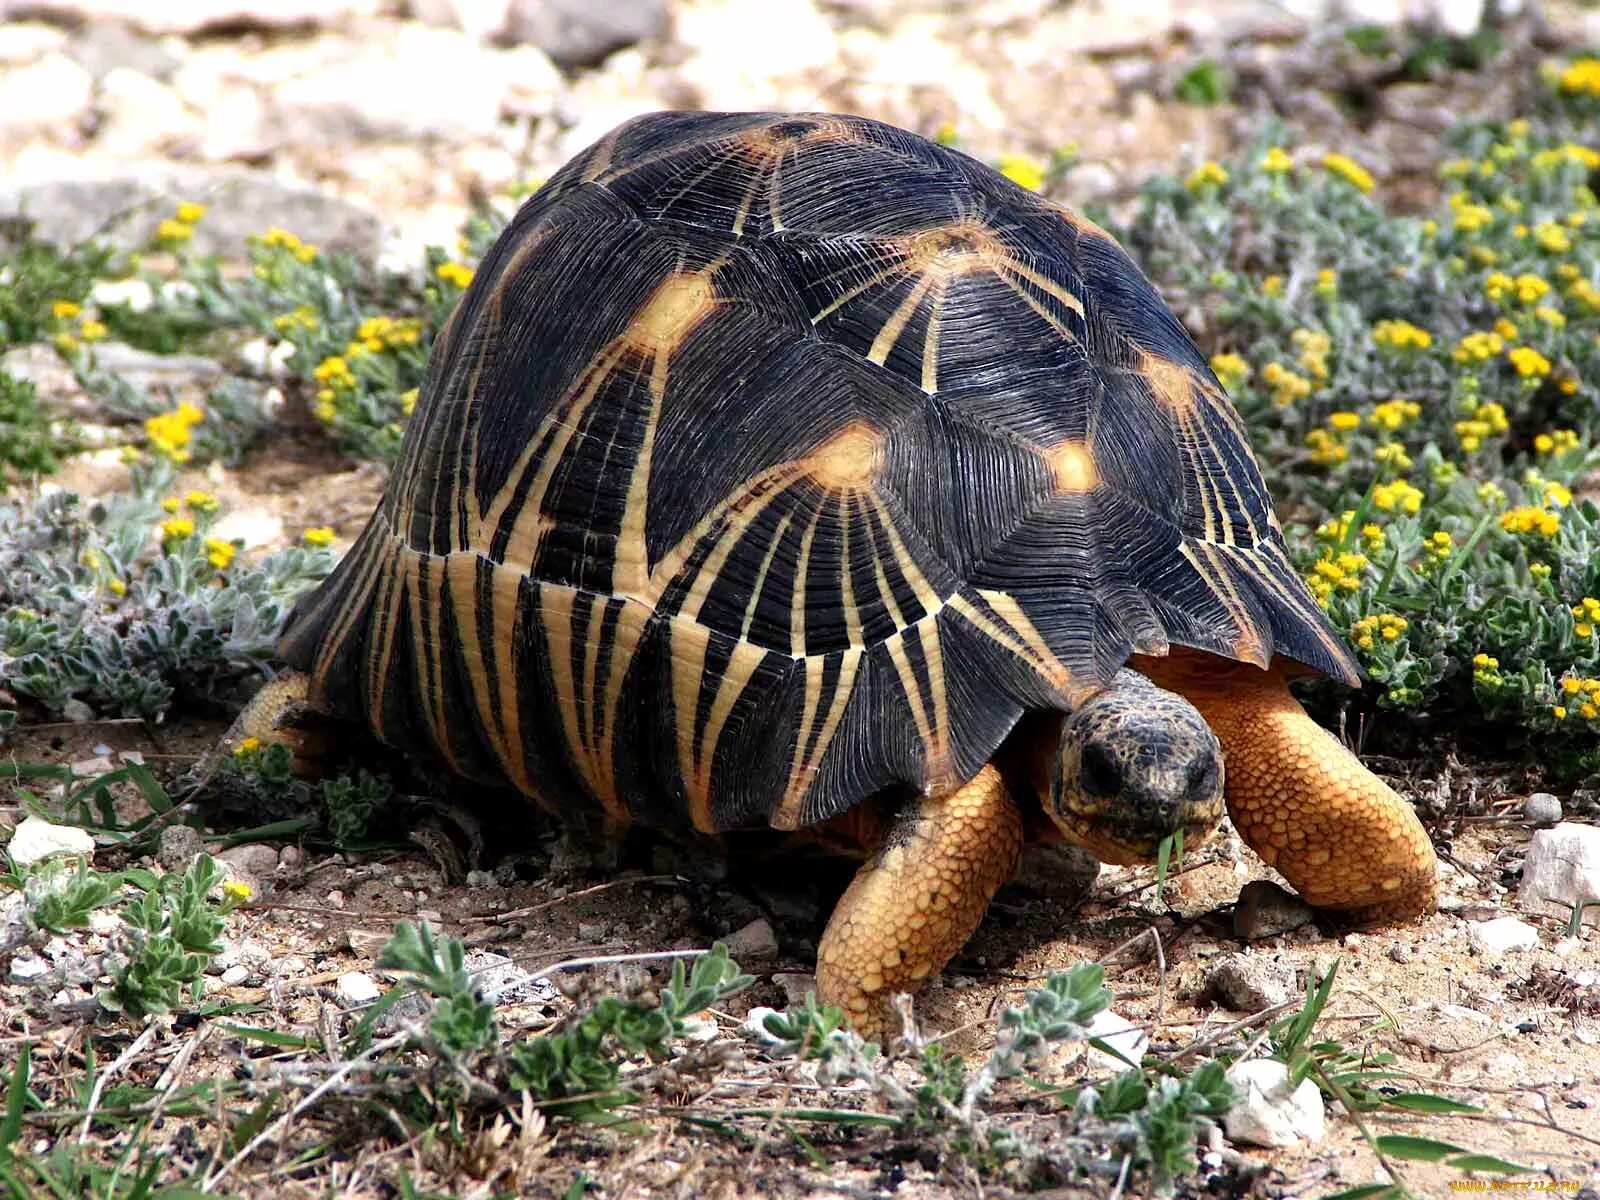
[816,765,1022,1042]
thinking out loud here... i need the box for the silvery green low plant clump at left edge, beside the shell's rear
[0,472,334,728]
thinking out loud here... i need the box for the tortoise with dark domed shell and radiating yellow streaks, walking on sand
[235,112,1434,1035]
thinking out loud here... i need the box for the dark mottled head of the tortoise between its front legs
[1045,669,1222,864]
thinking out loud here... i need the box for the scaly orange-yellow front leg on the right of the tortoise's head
[1134,651,1437,923]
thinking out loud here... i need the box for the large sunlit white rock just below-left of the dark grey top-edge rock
[272,24,510,146]
